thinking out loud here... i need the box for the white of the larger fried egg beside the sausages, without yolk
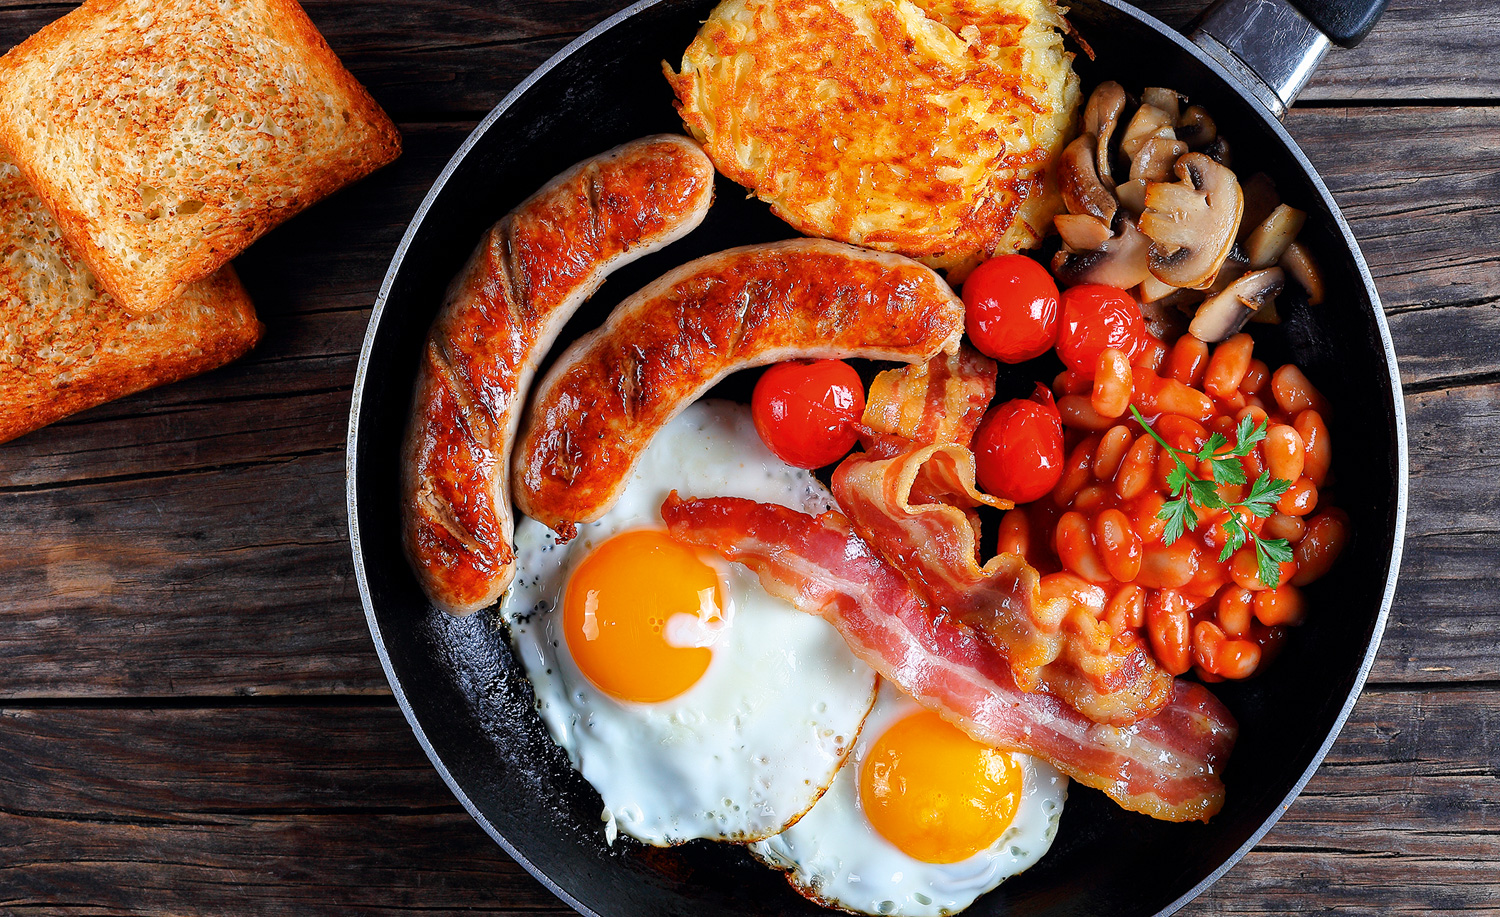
[501,401,878,845]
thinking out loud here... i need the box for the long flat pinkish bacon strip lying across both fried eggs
[662,494,1238,821]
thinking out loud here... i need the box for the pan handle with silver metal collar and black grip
[1191,0,1386,119]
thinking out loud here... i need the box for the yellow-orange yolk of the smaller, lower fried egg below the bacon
[860,710,1022,863]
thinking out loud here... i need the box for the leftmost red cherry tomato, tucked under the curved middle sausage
[750,360,864,468]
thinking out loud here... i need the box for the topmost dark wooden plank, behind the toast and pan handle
[0,0,1500,119]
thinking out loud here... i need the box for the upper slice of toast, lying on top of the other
[0,0,401,314]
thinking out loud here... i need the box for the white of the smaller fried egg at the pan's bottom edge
[750,681,1068,917]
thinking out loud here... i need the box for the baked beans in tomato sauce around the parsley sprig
[999,333,1349,681]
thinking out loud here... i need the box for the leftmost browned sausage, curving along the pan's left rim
[401,135,714,614]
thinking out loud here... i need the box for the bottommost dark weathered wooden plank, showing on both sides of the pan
[0,690,1500,915]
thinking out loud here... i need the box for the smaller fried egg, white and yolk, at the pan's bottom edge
[750,683,1068,917]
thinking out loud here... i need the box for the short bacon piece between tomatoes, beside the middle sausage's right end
[860,344,998,456]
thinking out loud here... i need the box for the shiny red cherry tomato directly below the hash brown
[963,255,1058,363]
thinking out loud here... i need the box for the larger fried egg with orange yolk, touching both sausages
[501,401,878,845]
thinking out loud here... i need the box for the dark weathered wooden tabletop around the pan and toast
[0,0,1500,915]
